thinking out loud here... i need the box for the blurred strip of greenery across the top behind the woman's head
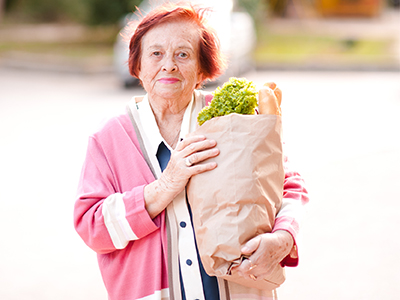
[0,0,400,77]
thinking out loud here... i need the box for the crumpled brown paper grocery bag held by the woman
[187,114,285,289]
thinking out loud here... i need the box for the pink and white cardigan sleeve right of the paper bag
[272,156,309,267]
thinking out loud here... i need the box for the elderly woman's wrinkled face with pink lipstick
[139,21,202,101]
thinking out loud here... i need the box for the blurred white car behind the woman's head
[114,0,256,87]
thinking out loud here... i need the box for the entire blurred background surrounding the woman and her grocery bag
[0,0,400,300]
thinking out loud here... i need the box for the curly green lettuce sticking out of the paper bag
[197,77,257,125]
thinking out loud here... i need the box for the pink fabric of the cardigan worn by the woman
[74,114,308,300]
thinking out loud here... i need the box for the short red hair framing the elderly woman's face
[128,3,225,88]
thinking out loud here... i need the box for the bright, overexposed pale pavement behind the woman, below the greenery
[0,69,400,300]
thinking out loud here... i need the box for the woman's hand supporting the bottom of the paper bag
[233,230,297,280]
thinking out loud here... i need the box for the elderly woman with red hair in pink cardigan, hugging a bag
[74,5,308,300]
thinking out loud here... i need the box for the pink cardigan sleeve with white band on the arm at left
[74,137,160,253]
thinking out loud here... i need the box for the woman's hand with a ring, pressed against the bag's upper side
[144,135,219,218]
